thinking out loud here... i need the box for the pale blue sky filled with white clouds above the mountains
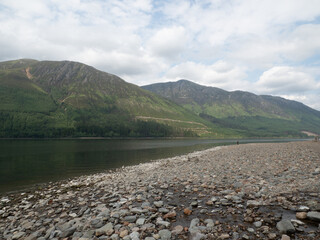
[0,0,320,110]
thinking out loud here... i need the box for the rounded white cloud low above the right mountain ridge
[256,66,318,94]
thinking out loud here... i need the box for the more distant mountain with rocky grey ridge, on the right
[142,80,320,137]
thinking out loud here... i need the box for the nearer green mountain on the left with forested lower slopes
[0,59,219,137]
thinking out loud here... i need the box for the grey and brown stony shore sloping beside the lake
[0,141,320,240]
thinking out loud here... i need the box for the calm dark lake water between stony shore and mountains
[0,139,304,193]
